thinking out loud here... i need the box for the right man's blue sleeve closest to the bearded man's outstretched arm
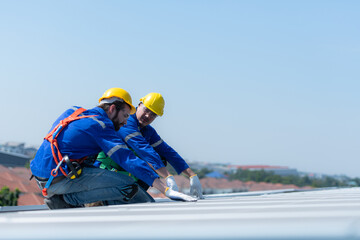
[118,126,165,170]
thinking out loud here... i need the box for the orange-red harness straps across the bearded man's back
[44,108,96,177]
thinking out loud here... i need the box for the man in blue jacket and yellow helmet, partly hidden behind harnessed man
[97,93,203,199]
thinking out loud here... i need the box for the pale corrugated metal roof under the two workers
[0,188,360,240]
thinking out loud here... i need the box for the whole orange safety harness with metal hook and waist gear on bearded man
[42,108,95,197]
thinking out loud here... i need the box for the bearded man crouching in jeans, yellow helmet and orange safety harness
[30,88,196,209]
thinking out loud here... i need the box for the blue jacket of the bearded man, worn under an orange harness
[30,107,159,186]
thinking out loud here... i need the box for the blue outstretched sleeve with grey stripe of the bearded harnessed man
[94,124,159,186]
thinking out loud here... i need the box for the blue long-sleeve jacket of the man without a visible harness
[118,114,189,174]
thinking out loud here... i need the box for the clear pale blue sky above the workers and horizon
[0,0,360,177]
